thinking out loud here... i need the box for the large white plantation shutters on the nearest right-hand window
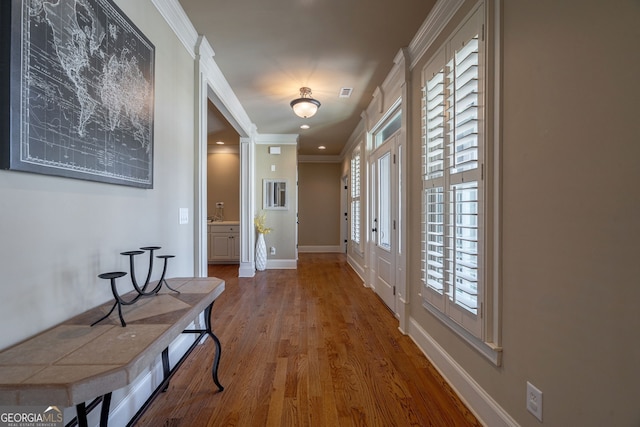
[422,8,483,337]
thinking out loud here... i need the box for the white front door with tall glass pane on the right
[371,138,396,314]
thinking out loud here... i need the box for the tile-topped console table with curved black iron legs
[0,277,225,427]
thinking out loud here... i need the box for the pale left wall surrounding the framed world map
[0,0,195,348]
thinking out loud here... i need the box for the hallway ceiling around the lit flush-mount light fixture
[179,0,435,155]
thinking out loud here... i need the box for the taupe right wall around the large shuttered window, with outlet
[408,0,640,427]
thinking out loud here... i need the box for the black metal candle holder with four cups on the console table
[91,246,180,327]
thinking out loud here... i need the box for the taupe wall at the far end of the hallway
[298,162,342,247]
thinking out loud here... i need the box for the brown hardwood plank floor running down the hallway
[137,254,481,427]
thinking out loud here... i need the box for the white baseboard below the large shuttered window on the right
[409,318,519,427]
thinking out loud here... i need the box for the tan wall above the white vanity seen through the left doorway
[207,153,240,221]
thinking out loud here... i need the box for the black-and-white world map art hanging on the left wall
[0,0,155,188]
